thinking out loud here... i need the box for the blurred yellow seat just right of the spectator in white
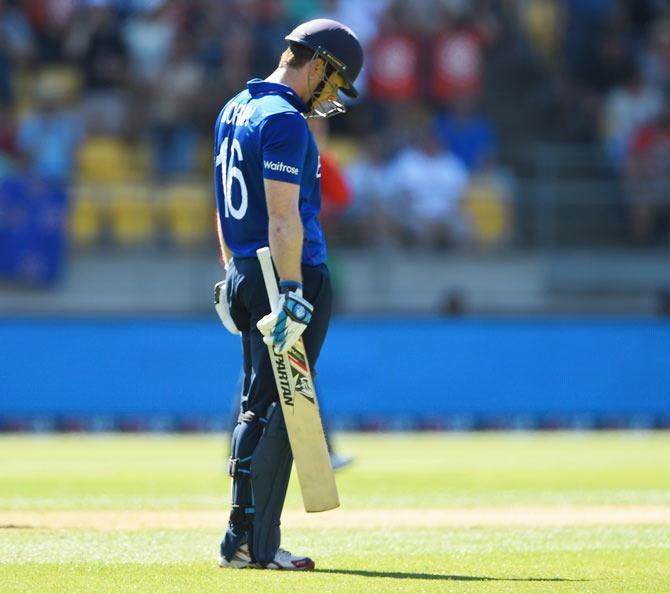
[463,176,511,247]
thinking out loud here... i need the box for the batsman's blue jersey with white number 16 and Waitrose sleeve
[214,79,326,265]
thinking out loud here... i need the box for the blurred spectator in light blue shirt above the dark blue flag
[17,76,83,185]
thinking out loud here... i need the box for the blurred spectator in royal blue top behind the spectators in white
[435,93,496,172]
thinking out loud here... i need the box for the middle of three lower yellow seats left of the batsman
[108,183,156,246]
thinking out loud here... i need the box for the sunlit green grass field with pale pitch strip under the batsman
[0,433,670,594]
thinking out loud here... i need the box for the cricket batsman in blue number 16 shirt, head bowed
[215,19,363,570]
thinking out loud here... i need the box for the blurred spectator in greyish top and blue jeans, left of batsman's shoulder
[149,36,203,181]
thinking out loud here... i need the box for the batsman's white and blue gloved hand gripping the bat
[256,281,314,354]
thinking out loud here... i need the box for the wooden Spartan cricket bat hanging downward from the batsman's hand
[256,247,340,512]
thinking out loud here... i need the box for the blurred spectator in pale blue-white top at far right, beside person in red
[603,70,661,169]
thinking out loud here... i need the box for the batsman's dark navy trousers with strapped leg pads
[221,258,332,564]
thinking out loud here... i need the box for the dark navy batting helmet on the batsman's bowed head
[285,19,363,97]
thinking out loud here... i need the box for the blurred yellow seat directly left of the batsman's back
[162,182,215,248]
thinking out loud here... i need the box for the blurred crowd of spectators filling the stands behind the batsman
[0,0,670,272]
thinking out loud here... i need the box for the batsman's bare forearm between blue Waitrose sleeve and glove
[265,179,303,282]
